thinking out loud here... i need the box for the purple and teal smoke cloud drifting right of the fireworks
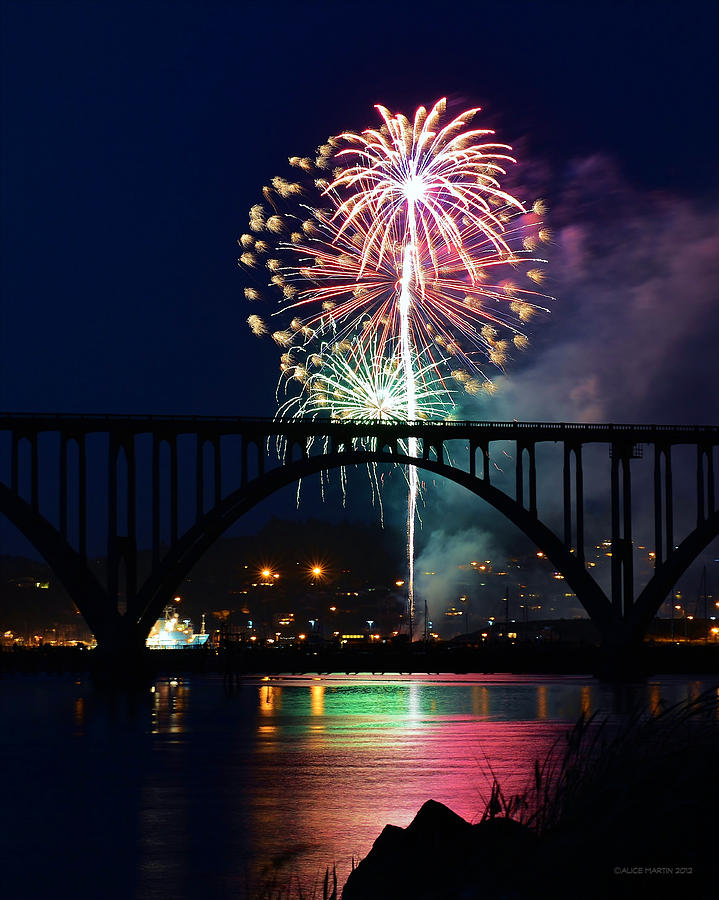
[417,155,719,631]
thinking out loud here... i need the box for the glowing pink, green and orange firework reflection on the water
[245,676,576,878]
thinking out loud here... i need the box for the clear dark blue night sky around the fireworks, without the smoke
[0,0,718,415]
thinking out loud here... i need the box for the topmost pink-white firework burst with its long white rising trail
[328,102,544,639]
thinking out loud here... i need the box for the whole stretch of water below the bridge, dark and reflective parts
[0,675,710,900]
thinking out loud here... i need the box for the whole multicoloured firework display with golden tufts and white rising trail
[238,100,550,640]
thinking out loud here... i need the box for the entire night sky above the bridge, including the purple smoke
[0,0,719,584]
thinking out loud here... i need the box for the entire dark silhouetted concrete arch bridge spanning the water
[0,413,719,653]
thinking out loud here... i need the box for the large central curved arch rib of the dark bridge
[136,447,620,639]
